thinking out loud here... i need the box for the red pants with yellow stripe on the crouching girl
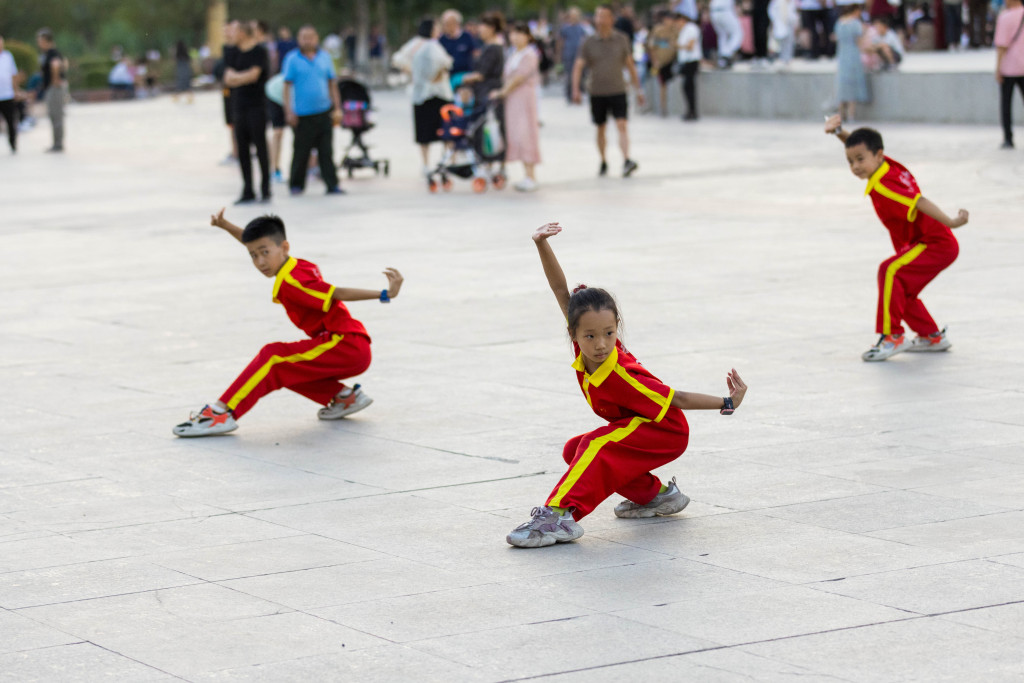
[547,409,689,521]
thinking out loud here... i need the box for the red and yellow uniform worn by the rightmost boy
[864,157,959,337]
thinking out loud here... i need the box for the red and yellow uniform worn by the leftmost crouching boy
[220,258,370,418]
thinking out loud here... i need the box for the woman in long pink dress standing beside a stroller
[495,23,541,193]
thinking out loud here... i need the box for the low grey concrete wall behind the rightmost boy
[647,71,1024,126]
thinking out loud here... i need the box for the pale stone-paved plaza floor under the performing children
[0,87,1024,683]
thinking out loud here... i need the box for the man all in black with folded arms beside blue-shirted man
[224,22,270,204]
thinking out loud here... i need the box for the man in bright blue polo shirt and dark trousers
[282,25,344,195]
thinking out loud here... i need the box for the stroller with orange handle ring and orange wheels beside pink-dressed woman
[427,97,508,193]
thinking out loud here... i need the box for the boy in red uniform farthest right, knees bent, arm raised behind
[825,116,968,360]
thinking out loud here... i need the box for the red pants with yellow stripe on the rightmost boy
[876,241,959,336]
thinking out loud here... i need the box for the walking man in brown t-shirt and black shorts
[572,5,644,178]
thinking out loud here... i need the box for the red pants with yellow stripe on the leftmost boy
[220,332,370,418]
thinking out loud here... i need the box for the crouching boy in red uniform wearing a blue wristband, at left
[173,209,402,436]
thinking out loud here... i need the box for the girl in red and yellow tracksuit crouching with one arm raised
[506,223,746,548]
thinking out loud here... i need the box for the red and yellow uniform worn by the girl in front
[547,341,690,521]
